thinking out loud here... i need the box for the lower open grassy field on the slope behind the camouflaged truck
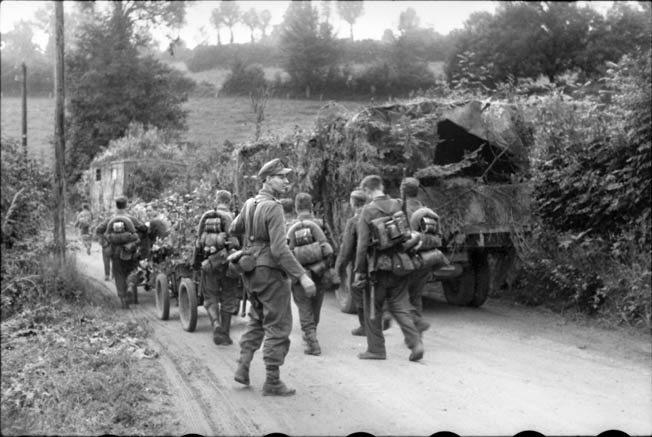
[0,97,362,162]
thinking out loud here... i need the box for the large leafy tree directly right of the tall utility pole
[66,2,193,185]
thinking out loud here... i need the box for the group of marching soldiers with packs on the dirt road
[96,159,447,396]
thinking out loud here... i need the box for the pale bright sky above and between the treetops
[0,0,612,48]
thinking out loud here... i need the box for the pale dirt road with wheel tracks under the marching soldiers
[78,243,652,436]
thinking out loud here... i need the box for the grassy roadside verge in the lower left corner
[0,258,179,435]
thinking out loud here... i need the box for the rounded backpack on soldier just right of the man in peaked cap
[287,219,333,274]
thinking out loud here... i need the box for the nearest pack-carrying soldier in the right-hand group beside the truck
[353,175,424,361]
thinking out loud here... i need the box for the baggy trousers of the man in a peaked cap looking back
[240,266,292,366]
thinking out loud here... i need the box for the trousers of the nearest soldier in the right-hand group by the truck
[363,272,421,354]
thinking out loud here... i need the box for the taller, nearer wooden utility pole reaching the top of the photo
[54,1,66,265]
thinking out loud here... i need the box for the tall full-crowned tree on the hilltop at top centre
[280,2,337,98]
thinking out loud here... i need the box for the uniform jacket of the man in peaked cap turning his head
[229,188,305,279]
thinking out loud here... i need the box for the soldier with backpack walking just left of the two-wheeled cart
[95,196,147,309]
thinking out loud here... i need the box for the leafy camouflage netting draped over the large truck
[229,99,532,240]
